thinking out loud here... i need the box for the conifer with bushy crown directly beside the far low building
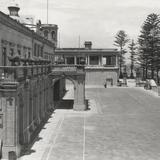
[114,30,129,78]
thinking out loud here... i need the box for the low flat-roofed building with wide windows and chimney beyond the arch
[55,41,119,86]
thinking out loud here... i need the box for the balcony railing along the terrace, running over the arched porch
[0,65,85,82]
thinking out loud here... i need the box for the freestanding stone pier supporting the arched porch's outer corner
[73,75,87,111]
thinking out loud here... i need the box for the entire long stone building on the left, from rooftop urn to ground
[0,4,65,159]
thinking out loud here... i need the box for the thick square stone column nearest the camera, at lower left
[0,82,21,159]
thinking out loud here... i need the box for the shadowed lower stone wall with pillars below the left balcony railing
[0,66,65,159]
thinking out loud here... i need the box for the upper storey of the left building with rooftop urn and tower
[0,0,58,66]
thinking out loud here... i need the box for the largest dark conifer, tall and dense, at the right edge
[138,13,160,79]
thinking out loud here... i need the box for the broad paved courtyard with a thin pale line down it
[20,88,160,160]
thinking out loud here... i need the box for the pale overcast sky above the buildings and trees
[0,0,160,48]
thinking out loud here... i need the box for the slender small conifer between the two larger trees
[128,39,137,78]
